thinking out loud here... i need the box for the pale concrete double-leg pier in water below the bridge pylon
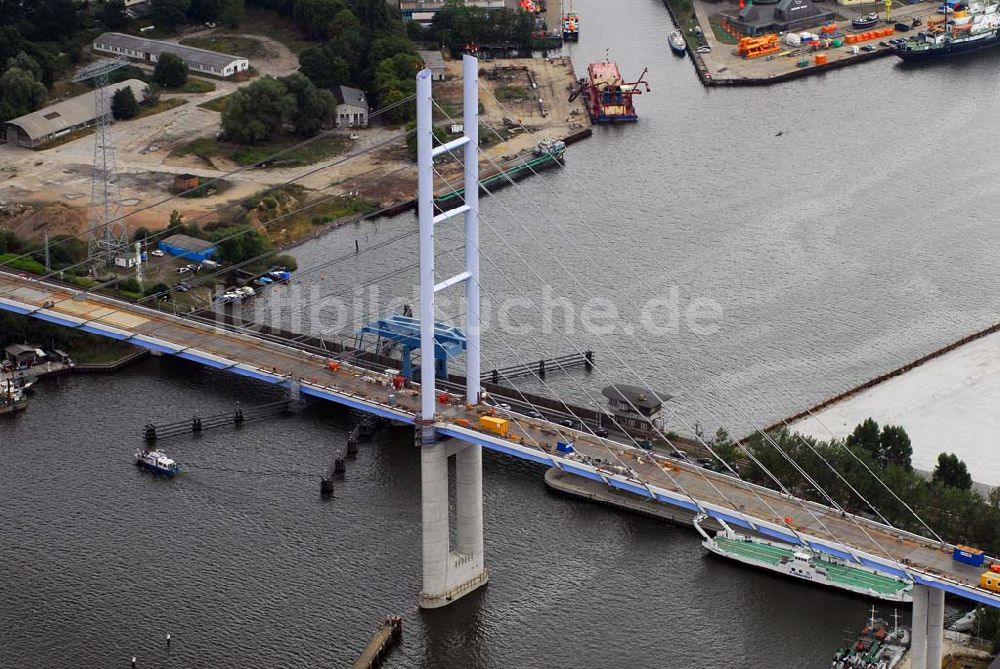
[420,440,489,609]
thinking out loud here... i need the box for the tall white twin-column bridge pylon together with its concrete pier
[417,56,489,609]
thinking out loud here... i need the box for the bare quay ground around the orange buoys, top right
[689,0,940,83]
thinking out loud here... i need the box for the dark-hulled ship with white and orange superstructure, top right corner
[896,3,1000,61]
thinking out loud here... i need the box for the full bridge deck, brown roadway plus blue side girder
[0,271,1000,607]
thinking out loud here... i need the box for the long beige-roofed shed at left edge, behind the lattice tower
[3,79,146,148]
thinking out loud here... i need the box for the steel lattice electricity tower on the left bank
[73,57,128,266]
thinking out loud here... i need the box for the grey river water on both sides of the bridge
[0,0,1000,667]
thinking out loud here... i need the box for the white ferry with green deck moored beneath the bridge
[695,518,913,602]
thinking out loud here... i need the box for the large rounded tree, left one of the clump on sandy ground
[222,77,296,144]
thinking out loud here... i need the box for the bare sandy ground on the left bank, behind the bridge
[0,45,589,243]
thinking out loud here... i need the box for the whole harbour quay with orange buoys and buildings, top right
[664,0,941,86]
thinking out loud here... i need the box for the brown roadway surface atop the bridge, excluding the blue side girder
[0,272,1000,605]
